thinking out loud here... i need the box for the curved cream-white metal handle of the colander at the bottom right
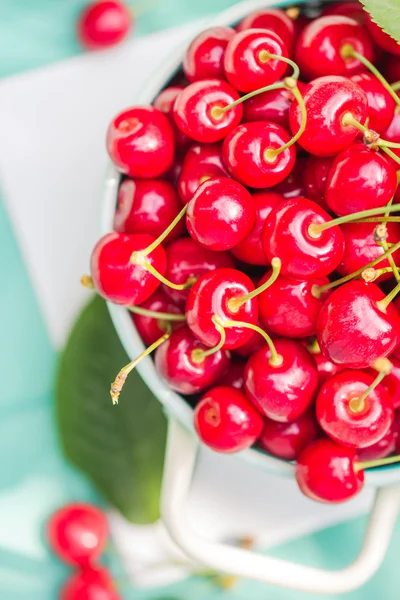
[161,417,400,594]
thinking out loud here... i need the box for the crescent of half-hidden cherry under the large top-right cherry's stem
[351,73,398,133]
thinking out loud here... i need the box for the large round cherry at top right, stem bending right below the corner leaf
[295,15,374,79]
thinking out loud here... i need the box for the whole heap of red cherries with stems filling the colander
[84,2,400,502]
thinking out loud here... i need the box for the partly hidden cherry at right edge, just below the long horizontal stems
[337,223,400,282]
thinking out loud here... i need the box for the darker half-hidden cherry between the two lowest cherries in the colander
[258,410,320,460]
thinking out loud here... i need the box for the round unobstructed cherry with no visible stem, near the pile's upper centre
[186,177,256,250]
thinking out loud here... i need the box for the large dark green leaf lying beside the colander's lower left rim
[56,297,167,523]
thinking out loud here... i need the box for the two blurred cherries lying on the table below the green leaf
[47,503,120,600]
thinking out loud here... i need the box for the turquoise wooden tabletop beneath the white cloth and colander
[0,0,400,600]
